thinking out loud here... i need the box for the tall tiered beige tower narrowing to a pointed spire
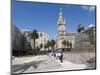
[57,8,66,48]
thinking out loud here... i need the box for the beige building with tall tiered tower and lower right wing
[56,9,77,49]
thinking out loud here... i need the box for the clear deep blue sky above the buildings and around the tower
[11,0,96,39]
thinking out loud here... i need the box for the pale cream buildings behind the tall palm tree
[21,29,49,50]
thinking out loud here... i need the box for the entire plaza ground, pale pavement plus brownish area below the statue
[12,52,95,73]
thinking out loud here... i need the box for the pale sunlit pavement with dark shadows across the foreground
[12,55,94,73]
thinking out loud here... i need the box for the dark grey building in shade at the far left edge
[11,25,26,56]
